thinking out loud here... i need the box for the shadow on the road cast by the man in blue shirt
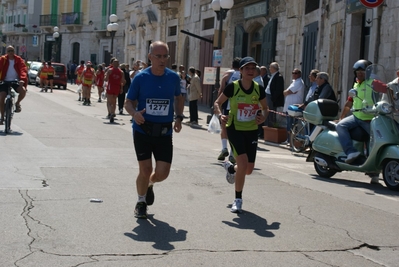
[125,215,187,250]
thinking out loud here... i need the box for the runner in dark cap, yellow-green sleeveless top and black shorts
[214,57,269,213]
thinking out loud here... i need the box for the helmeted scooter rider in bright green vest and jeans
[336,59,378,183]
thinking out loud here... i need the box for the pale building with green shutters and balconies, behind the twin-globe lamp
[40,0,126,64]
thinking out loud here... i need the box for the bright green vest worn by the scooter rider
[352,79,374,121]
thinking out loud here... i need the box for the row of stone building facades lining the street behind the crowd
[0,0,399,111]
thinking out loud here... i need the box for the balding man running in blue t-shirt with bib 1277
[125,41,184,219]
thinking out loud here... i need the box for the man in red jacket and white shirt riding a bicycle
[0,45,28,125]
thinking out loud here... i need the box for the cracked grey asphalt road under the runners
[0,86,399,267]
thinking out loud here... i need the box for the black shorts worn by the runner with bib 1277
[133,131,173,163]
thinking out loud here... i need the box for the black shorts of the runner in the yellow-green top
[226,127,258,163]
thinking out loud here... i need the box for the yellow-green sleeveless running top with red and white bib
[226,81,262,131]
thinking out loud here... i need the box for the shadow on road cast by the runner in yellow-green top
[222,210,280,237]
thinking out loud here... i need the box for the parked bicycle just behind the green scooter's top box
[288,105,310,152]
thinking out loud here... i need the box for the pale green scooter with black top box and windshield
[303,64,399,190]
